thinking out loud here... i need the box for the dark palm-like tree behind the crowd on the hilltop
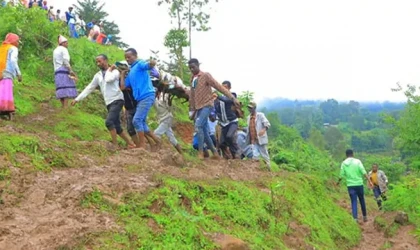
[73,0,128,48]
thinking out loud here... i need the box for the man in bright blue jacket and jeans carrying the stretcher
[120,48,160,149]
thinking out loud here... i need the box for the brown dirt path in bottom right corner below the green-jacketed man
[354,211,420,250]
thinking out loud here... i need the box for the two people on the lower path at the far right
[337,149,388,222]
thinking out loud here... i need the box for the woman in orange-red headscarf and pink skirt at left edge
[0,33,22,120]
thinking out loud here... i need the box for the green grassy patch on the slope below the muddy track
[82,174,360,249]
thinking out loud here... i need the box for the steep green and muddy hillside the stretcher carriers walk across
[0,5,418,249]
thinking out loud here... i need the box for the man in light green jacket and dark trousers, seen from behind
[337,149,373,222]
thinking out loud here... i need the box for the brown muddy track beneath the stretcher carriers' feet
[0,146,270,250]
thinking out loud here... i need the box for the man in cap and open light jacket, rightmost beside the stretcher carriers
[247,102,271,170]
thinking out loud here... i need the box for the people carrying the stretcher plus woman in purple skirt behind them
[53,36,270,167]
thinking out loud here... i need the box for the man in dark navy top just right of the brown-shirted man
[214,81,240,159]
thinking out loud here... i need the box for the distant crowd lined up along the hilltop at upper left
[2,0,113,45]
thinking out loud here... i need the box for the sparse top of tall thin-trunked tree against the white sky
[158,0,218,59]
